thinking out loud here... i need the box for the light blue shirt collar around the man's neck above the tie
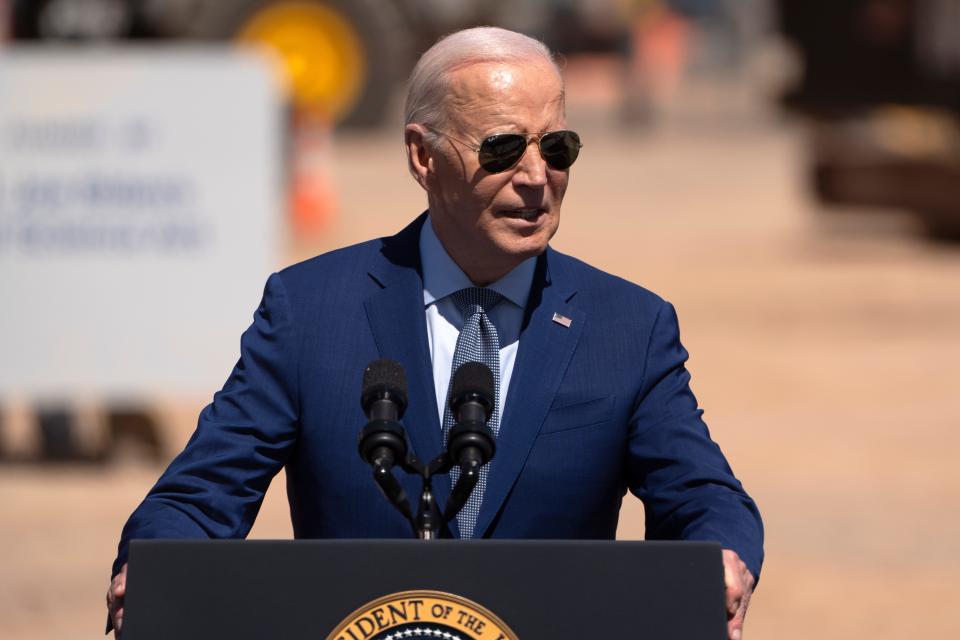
[420,216,537,309]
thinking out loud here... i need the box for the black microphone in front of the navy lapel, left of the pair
[357,358,412,520]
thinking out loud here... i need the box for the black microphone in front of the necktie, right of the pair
[443,362,496,522]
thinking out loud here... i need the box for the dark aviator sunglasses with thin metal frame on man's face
[425,125,583,173]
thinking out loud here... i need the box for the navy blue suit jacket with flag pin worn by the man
[114,216,763,576]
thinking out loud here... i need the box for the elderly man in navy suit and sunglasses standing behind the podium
[107,28,763,638]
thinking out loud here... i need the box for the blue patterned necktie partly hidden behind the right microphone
[443,287,503,539]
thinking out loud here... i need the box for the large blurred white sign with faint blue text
[0,48,283,399]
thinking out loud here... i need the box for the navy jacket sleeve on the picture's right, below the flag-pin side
[628,302,763,579]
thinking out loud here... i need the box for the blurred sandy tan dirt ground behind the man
[0,65,960,640]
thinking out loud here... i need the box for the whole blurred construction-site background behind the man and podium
[0,0,960,640]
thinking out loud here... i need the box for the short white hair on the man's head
[403,27,562,139]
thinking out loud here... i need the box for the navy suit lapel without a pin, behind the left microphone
[364,215,450,524]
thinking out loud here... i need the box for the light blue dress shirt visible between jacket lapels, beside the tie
[420,217,537,428]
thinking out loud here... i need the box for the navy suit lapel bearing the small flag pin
[474,249,586,533]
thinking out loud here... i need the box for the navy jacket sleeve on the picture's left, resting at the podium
[113,274,299,575]
